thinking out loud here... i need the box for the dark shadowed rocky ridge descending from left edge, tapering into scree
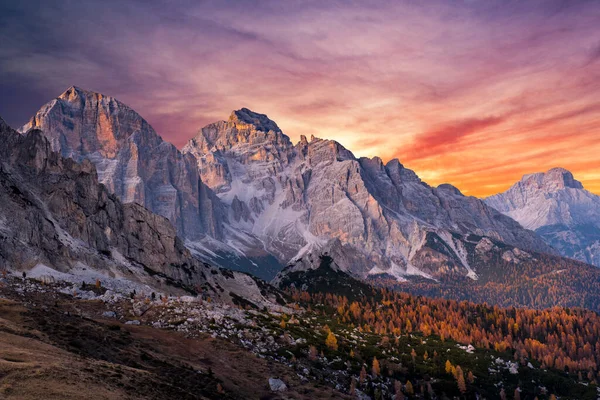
[0,118,280,307]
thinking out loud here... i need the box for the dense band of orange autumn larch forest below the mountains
[291,289,600,376]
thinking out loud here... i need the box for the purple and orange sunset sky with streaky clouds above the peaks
[0,0,600,197]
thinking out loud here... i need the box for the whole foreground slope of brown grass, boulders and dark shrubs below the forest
[0,274,597,400]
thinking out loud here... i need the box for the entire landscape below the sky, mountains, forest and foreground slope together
[0,87,600,399]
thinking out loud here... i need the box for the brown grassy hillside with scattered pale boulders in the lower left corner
[0,276,346,399]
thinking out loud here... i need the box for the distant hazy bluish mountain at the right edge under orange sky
[485,168,600,267]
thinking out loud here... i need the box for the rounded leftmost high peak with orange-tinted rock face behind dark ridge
[20,87,224,239]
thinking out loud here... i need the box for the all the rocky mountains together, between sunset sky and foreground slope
[2,87,599,308]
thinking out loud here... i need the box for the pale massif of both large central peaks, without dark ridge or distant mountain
[20,87,554,280]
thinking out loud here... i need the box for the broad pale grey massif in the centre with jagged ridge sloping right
[182,109,552,279]
